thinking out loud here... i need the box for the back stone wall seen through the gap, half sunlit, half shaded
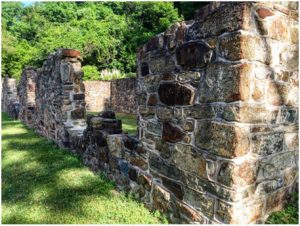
[84,78,137,114]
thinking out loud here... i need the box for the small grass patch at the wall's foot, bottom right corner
[266,192,299,224]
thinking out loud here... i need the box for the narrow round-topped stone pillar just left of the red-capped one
[18,67,37,127]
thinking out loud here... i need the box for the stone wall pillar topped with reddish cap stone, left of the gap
[35,49,86,148]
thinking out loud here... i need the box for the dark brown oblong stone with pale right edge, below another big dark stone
[158,83,195,106]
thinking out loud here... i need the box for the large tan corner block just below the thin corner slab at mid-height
[195,120,250,158]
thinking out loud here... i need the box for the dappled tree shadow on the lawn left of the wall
[2,112,117,223]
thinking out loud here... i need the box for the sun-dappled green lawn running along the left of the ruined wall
[2,113,166,224]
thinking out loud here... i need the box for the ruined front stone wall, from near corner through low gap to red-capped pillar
[12,2,298,224]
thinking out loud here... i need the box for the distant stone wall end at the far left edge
[1,76,19,119]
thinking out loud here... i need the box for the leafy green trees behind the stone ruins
[1,2,207,80]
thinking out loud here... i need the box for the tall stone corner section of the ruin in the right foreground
[138,2,298,224]
